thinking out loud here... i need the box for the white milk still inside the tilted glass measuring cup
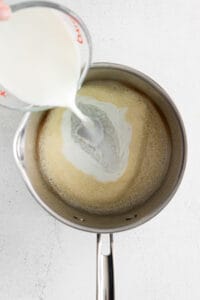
[0,7,82,111]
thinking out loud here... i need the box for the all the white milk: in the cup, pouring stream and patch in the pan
[0,7,132,181]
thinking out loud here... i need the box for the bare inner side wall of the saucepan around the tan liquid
[23,67,184,232]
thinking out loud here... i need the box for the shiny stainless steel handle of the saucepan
[97,234,115,300]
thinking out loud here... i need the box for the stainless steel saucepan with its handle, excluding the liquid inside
[14,63,186,300]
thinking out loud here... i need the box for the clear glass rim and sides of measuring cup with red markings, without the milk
[0,1,92,111]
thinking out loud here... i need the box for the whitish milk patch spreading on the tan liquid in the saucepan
[61,96,132,182]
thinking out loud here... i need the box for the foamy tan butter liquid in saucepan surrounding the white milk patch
[37,80,171,214]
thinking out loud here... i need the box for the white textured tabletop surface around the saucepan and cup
[0,0,200,300]
